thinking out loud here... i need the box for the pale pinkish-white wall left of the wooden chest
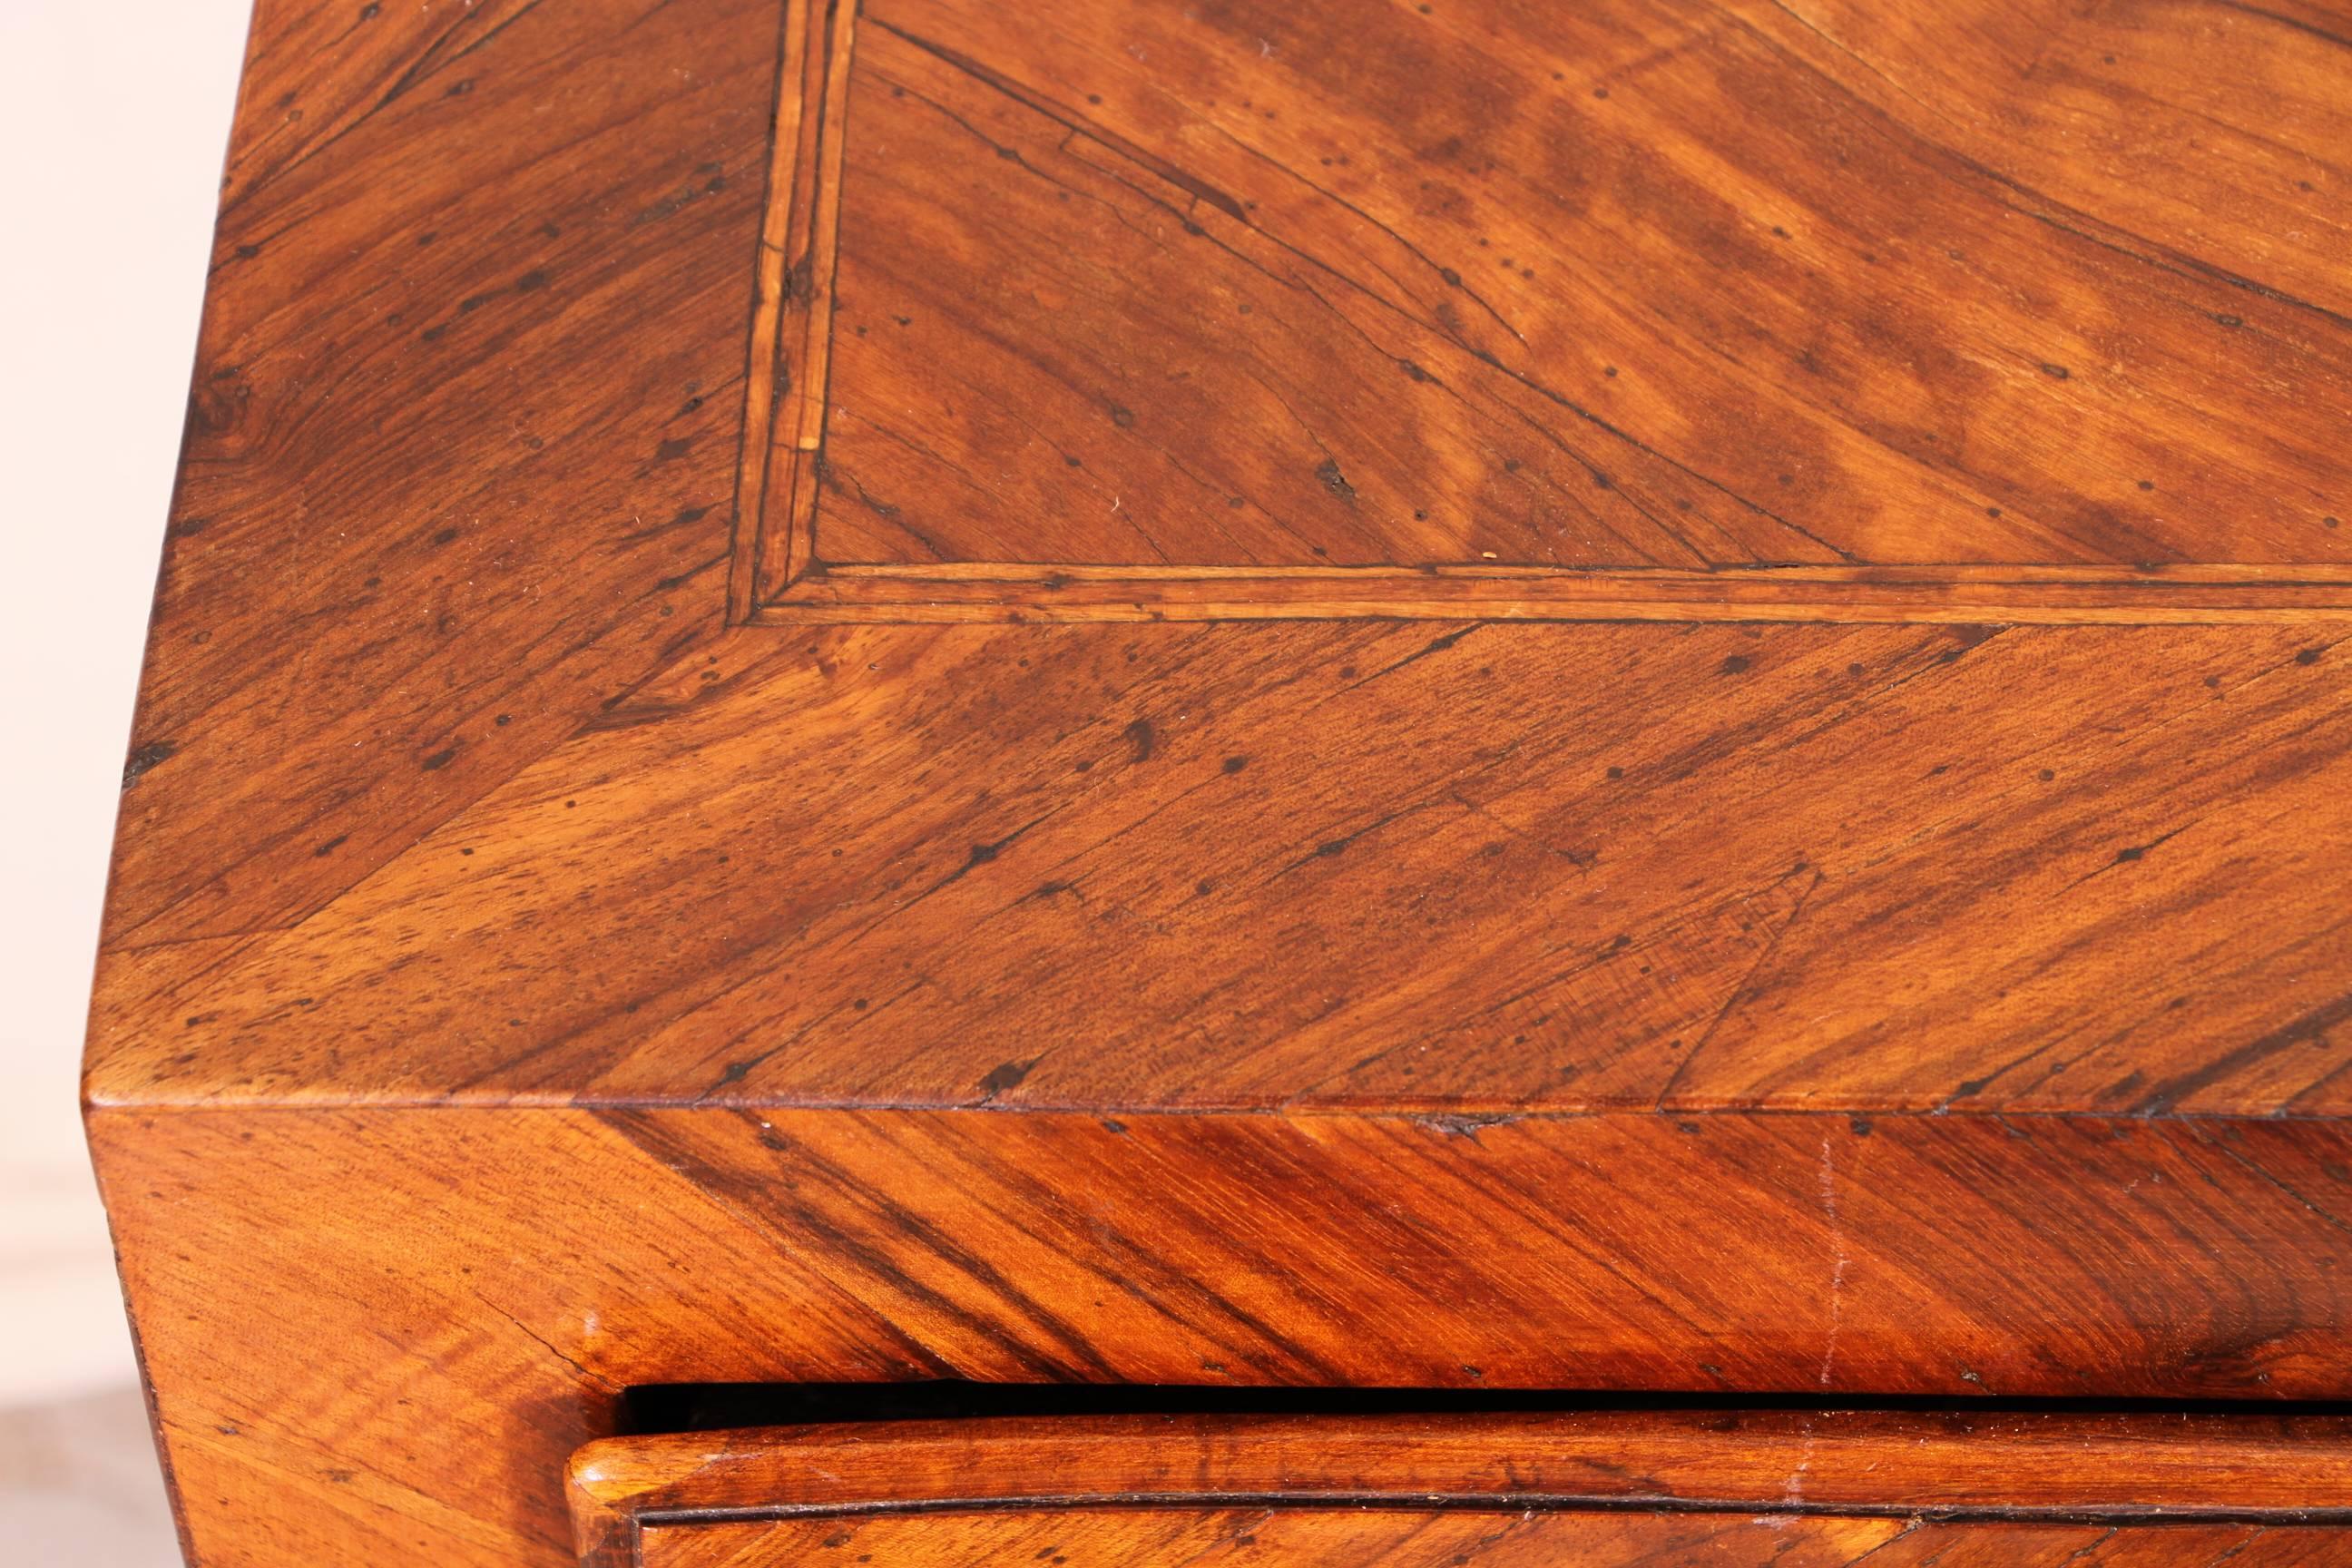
[0,0,255,1410]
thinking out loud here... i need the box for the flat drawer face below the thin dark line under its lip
[642,1507,2352,1568]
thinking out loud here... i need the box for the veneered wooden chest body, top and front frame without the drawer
[87,0,2352,1568]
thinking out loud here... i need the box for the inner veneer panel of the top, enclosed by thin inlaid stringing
[755,0,2352,621]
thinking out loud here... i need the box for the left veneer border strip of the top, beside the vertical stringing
[108,0,779,947]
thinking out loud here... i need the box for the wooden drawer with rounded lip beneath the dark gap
[569,1408,2352,1568]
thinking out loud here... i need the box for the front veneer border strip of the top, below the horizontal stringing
[92,623,2352,1114]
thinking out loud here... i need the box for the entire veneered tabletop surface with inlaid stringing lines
[92,0,2352,1117]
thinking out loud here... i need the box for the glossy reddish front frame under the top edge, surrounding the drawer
[92,1107,2352,1568]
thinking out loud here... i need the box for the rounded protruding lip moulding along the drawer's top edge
[569,1410,2352,1568]
